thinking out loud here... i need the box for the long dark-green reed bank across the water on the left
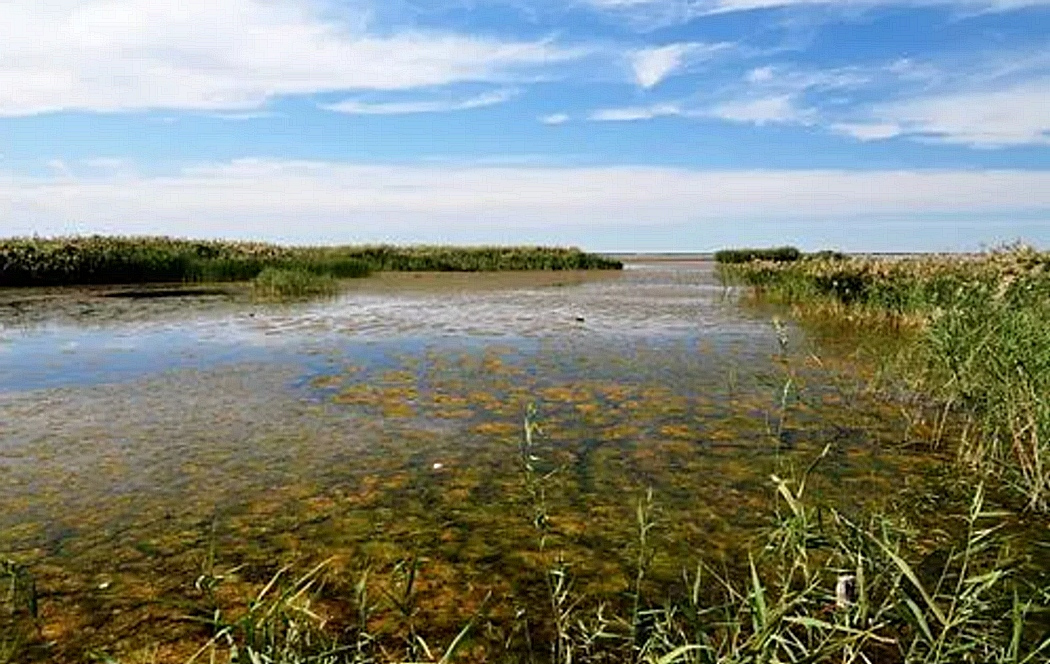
[0,236,623,287]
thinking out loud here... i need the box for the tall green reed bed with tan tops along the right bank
[720,247,1050,511]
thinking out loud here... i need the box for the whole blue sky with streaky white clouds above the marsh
[0,0,1050,251]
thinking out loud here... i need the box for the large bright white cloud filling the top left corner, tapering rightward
[0,0,579,116]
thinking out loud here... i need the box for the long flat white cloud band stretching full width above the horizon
[0,159,1050,242]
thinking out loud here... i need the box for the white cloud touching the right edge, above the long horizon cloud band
[872,78,1050,147]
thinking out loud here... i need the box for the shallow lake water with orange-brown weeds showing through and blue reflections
[0,261,1033,662]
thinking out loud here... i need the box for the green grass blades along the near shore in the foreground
[157,451,1050,664]
